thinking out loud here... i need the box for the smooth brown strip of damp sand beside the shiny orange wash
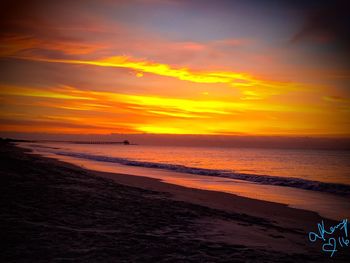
[16,145,330,225]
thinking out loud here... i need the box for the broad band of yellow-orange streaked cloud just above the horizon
[0,86,334,134]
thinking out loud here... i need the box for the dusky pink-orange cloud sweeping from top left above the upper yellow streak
[0,0,254,65]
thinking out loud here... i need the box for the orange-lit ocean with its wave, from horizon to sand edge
[20,143,350,219]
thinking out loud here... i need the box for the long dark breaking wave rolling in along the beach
[48,151,350,195]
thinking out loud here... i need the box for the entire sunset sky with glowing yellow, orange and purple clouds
[0,0,350,137]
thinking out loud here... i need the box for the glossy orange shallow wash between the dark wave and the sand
[24,144,350,220]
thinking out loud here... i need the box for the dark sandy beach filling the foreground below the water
[0,143,349,262]
